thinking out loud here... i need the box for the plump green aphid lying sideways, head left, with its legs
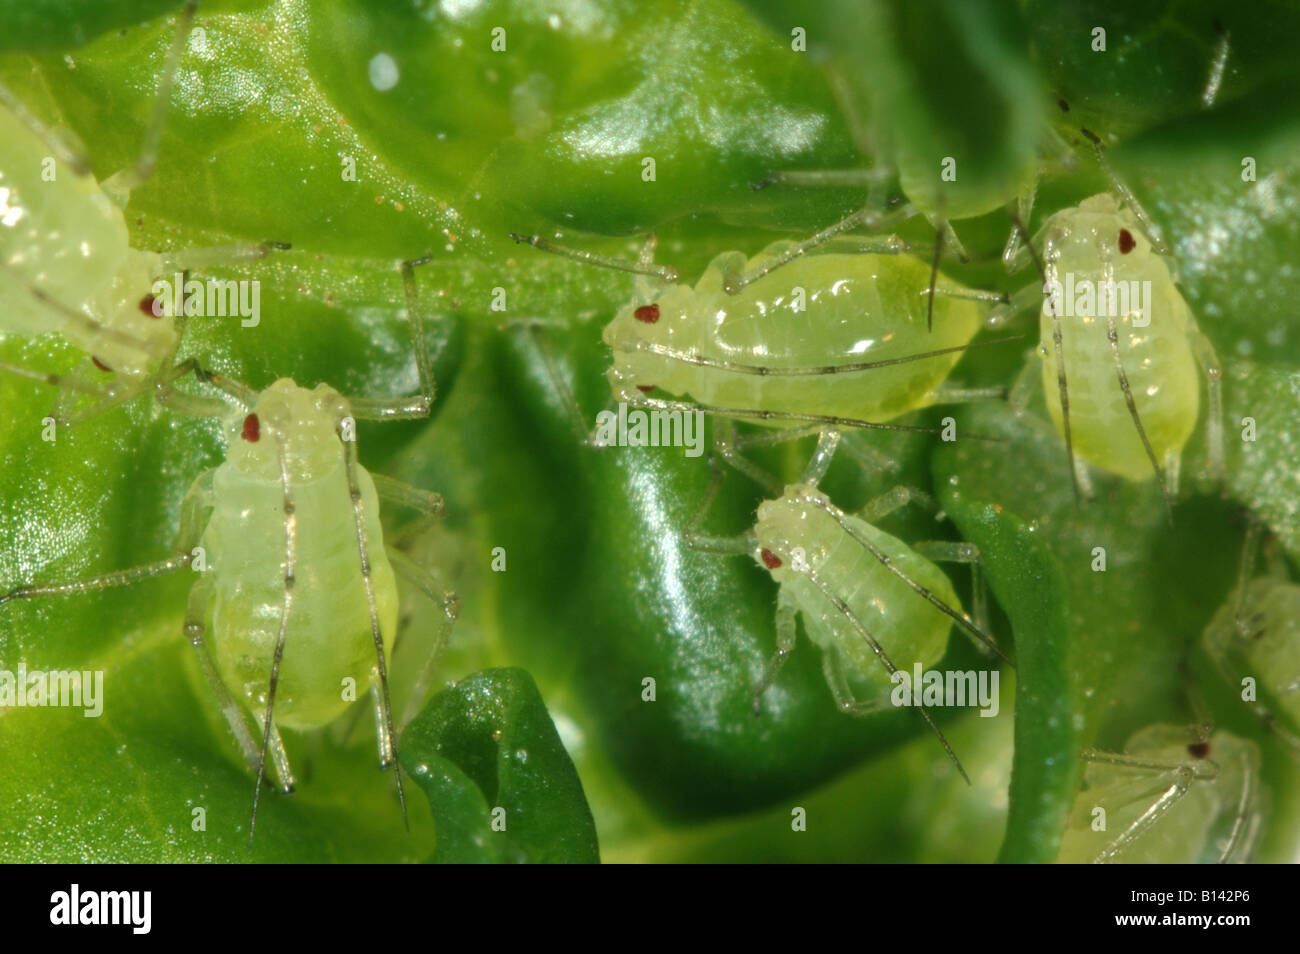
[514,226,1010,444]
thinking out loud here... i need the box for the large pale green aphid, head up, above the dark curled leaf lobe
[0,264,456,842]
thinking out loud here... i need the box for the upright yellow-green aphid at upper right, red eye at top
[991,192,1223,507]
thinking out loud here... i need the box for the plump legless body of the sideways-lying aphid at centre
[606,250,980,426]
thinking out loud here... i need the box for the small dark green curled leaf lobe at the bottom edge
[402,669,599,863]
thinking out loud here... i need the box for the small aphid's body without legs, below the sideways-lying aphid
[755,485,961,690]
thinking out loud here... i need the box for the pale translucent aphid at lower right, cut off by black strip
[1057,725,1262,864]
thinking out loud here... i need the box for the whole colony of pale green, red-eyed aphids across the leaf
[0,4,1284,862]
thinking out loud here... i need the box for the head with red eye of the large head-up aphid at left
[226,378,347,483]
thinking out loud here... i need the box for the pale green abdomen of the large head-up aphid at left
[203,460,398,729]
